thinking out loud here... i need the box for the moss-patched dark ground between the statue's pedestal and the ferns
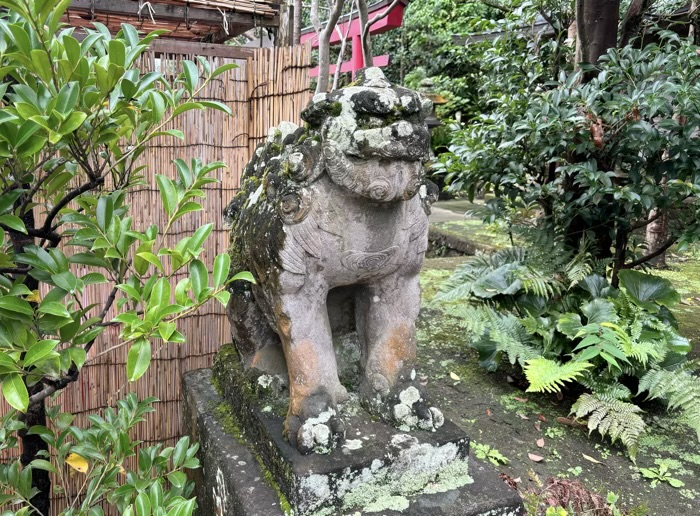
[418,217,700,515]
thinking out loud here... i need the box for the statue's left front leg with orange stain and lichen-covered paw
[275,277,348,453]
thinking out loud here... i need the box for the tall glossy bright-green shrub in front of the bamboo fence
[0,0,252,515]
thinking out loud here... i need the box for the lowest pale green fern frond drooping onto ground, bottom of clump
[571,393,646,460]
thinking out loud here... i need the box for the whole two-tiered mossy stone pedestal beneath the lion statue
[183,364,522,516]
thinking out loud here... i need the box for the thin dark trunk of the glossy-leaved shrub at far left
[9,200,51,516]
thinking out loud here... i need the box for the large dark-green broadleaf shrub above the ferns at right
[435,32,700,286]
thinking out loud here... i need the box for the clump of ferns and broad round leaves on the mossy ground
[435,245,700,458]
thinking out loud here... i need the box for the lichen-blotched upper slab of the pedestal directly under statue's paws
[214,347,476,514]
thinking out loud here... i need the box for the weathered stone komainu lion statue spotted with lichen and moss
[225,68,443,453]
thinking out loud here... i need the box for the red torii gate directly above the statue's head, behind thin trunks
[301,0,406,77]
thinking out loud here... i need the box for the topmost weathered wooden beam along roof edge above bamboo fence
[68,0,279,27]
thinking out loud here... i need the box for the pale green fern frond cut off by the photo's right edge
[639,360,700,439]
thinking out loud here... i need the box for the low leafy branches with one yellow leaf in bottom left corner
[0,394,199,516]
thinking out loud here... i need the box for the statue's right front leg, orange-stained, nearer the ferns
[357,273,444,430]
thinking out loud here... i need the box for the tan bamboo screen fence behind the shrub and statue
[0,41,311,514]
